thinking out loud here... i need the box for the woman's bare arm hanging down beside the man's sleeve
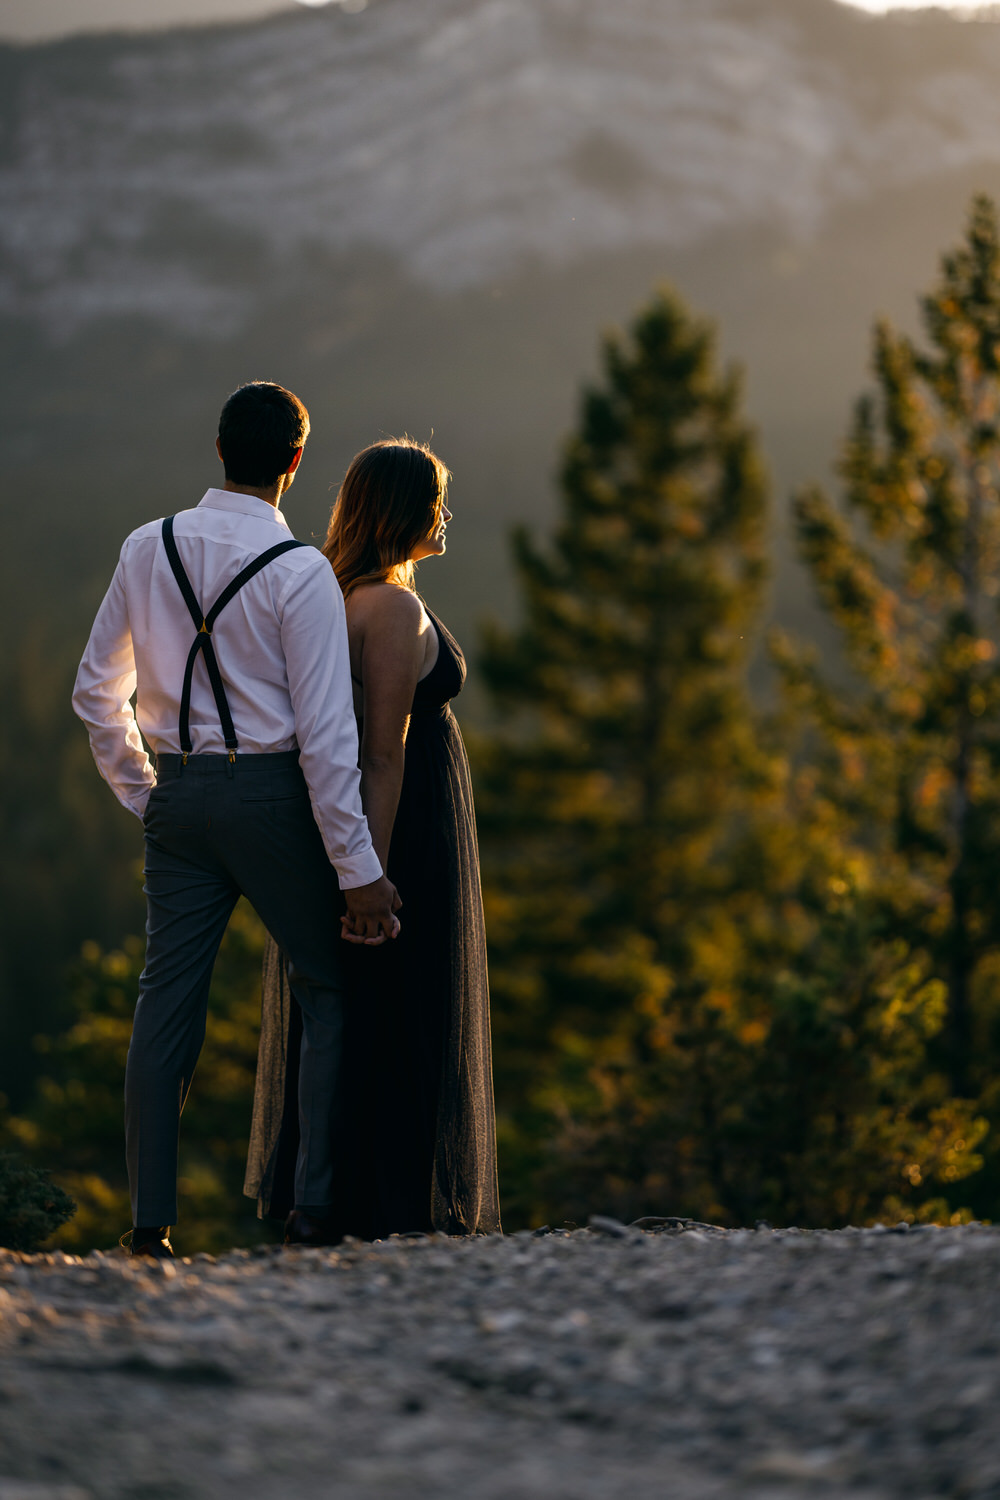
[358,584,433,870]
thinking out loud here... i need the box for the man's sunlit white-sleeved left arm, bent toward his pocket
[73,549,156,818]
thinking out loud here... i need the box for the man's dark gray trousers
[124,752,343,1226]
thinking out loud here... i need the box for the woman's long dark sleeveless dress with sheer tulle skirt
[244,615,501,1239]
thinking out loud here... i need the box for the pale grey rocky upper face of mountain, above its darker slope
[0,0,1000,336]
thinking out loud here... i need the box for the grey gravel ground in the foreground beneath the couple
[0,1220,1000,1500]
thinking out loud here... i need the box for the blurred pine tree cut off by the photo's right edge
[778,197,1000,1115]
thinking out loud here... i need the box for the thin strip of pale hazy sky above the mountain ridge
[0,0,995,42]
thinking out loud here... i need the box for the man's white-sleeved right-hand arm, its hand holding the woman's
[279,560,399,941]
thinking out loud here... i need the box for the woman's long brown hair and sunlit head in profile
[322,438,451,599]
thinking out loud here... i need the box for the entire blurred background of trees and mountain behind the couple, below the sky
[0,0,1000,1250]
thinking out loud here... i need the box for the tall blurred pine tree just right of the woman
[480,291,771,1230]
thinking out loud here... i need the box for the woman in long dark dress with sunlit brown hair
[246,438,499,1242]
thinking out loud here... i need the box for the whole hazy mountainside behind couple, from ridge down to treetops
[0,0,1000,629]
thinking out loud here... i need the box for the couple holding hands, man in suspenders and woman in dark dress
[73,381,499,1257]
